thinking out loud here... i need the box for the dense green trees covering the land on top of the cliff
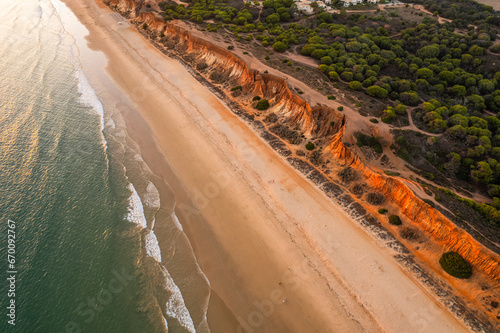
[154,0,500,233]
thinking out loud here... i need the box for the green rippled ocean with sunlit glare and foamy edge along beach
[0,0,209,333]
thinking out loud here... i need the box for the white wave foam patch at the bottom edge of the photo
[162,266,196,333]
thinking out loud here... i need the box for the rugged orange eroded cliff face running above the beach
[107,0,500,281]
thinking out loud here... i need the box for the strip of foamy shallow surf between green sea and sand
[57,1,210,332]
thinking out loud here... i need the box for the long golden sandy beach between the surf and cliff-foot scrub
[66,0,474,332]
